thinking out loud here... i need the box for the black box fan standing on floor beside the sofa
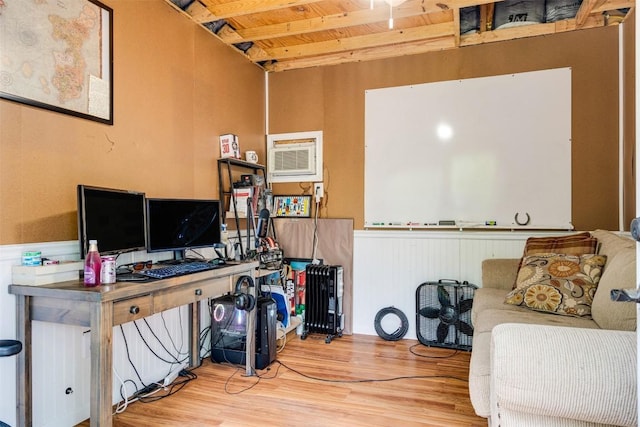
[416,280,477,351]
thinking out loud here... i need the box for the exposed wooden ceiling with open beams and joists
[165,0,635,71]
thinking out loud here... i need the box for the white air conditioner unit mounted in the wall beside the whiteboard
[267,132,322,182]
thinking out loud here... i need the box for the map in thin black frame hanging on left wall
[0,0,113,125]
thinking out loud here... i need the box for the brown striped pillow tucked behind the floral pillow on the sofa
[512,231,598,289]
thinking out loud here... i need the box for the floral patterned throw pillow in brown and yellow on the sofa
[505,254,607,317]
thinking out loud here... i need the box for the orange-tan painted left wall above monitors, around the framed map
[0,0,265,244]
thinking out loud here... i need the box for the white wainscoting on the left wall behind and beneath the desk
[0,241,210,427]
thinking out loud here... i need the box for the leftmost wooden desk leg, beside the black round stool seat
[15,295,33,426]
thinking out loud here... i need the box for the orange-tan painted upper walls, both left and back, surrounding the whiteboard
[0,0,632,244]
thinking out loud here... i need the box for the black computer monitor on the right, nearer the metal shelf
[147,198,220,261]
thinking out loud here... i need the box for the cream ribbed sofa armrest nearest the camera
[491,323,638,426]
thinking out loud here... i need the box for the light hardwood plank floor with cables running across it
[80,334,487,427]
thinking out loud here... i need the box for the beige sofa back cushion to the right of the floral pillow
[591,247,636,331]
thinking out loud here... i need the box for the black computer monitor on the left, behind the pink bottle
[77,184,146,259]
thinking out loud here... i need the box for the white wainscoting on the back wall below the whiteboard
[353,230,566,339]
